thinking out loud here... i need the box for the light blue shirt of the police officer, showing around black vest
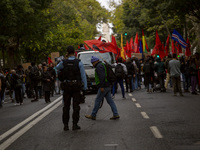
[56,56,87,90]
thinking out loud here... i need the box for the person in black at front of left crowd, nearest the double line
[42,66,52,103]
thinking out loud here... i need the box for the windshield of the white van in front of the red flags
[78,52,113,66]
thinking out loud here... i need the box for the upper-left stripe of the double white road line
[0,96,62,141]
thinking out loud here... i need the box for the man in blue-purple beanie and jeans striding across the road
[85,56,120,120]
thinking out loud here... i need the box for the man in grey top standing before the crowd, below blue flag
[169,54,183,96]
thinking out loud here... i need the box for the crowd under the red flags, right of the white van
[112,53,200,98]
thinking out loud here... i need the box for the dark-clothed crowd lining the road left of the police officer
[0,62,60,107]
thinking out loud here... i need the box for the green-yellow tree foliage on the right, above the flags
[112,0,200,51]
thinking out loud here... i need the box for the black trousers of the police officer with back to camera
[62,87,80,125]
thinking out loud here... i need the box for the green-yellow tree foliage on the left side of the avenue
[0,0,109,67]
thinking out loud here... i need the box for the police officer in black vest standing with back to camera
[56,46,87,131]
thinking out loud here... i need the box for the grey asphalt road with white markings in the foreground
[0,89,200,150]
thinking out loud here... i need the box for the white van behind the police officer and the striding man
[77,51,116,92]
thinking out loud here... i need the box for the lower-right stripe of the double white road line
[0,101,62,150]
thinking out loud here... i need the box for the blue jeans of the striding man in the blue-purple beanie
[91,87,119,117]
